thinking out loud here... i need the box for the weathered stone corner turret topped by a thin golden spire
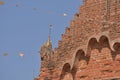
[40,25,53,68]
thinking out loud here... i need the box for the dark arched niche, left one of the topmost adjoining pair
[87,38,99,56]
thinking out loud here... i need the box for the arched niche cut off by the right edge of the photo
[112,42,120,60]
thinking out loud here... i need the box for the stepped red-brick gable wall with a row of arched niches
[36,0,120,80]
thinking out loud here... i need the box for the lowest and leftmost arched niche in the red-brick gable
[60,63,73,80]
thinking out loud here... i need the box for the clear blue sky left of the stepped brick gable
[0,0,82,80]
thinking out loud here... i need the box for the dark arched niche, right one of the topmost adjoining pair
[99,35,110,50]
